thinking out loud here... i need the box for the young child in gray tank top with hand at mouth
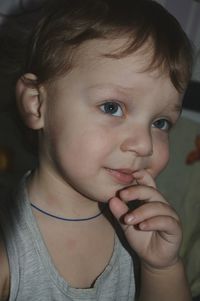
[0,0,194,301]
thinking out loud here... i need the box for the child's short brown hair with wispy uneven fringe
[23,0,192,92]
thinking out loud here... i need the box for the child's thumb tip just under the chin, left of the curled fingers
[109,197,129,228]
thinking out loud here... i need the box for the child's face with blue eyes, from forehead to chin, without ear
[39,40,181,201]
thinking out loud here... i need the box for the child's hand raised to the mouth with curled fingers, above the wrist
[109,170,182,269]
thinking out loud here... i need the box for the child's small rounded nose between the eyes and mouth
[120,126,153,157]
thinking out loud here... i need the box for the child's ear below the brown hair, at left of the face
[16,73,44,130]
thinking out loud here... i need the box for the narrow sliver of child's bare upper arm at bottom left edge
[0,241,10,301]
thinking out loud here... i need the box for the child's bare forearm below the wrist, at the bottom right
[139,260,192,301]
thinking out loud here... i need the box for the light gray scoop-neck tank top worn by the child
[5,175,135,301]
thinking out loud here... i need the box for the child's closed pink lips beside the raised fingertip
[106,168,135,185]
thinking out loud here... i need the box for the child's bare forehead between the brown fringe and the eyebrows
[72,38,178,95]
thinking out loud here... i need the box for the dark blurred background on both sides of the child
[0,0,200,300]
